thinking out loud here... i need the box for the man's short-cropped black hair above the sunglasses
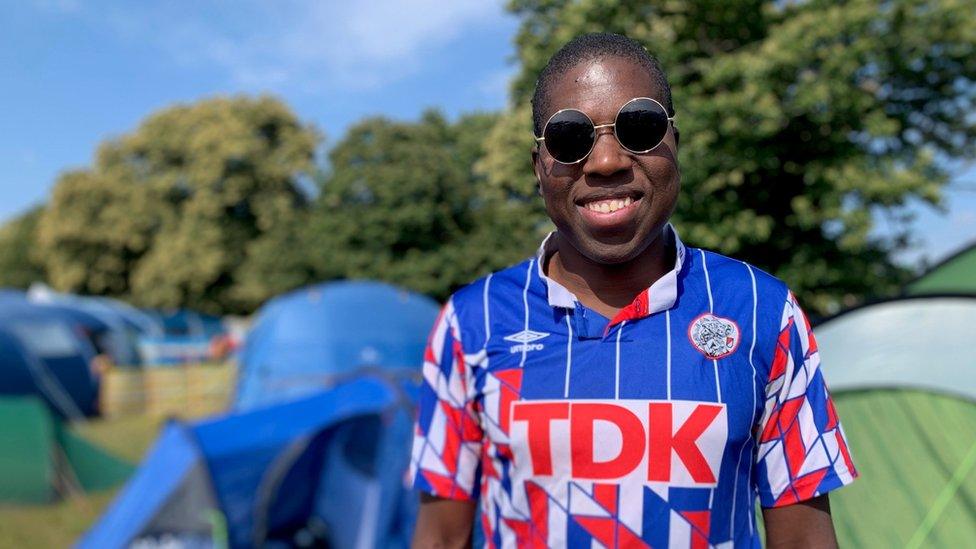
[532,32,674,136]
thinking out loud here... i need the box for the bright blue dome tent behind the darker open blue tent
[235,281,439,410]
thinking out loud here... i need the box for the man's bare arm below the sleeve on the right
[763,494,837,549]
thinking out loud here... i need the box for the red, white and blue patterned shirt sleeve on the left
[410,301,484,500]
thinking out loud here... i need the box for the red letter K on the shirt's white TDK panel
[647,402,722,483]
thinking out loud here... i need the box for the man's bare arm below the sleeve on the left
[411,492,476,549]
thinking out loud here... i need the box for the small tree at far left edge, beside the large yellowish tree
[0,207,46,289]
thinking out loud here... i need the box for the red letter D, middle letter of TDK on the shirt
[572,403,644,479]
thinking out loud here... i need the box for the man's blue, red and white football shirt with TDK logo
[411,229,857,547]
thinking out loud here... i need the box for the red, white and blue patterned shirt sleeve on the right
[753,293,857,507]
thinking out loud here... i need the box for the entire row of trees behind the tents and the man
[15,0,976,313]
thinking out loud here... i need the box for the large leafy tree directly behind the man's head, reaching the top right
[481,0,976,313]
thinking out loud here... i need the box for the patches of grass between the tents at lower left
[0,415,165,549]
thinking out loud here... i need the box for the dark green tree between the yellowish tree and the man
[306,111,533,299]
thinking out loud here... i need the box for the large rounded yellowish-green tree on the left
[39,97,319,313]
